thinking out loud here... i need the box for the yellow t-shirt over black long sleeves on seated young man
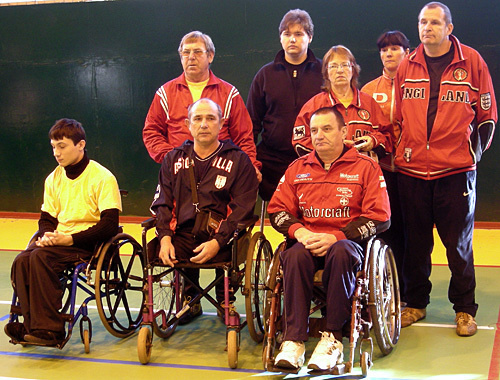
[42,160,122,234]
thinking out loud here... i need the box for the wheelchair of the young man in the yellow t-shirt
[9,227,144,353]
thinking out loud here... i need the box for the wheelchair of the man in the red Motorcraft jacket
[262,237,401,377]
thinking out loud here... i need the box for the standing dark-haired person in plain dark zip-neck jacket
[247,9,323,200]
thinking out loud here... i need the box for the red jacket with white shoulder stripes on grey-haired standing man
[142,71,261,169]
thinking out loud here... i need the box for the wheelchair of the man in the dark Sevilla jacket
[137,216,272,369]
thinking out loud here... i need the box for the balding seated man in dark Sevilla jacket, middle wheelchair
[151,98,258,324]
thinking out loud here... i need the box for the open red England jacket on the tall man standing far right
[396,35,497,180]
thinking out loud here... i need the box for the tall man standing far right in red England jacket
[395,2,497,336]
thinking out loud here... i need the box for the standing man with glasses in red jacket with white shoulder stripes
[142,31,261,180]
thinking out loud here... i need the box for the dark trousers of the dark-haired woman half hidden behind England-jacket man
[378,170,406,301]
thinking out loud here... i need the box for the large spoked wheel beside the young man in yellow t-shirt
[95,233,145,338]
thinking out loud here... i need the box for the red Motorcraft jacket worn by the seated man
[267,146,391,242]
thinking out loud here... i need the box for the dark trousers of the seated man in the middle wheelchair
[172,230,232,303]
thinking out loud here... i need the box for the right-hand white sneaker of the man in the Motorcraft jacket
[307,332,344,371]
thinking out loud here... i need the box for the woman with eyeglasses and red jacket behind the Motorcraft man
[292,45,393,160]
